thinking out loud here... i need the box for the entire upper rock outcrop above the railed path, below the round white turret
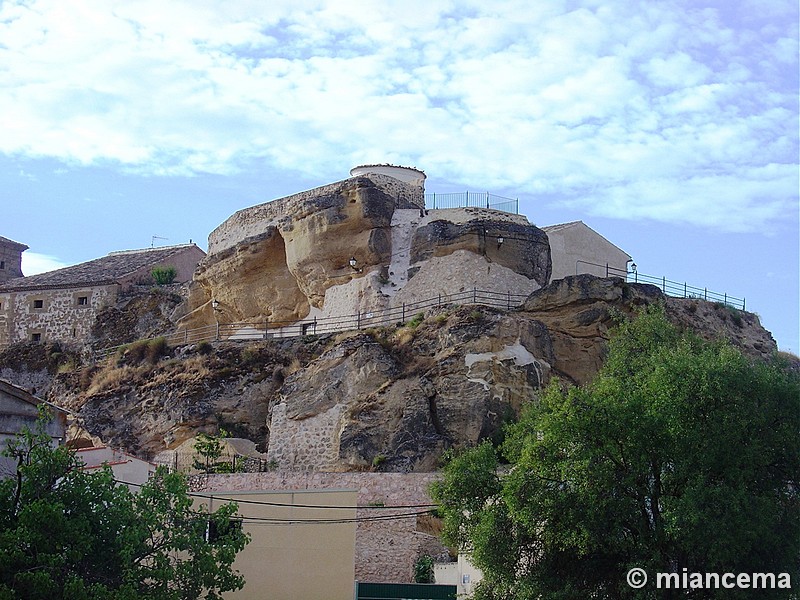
[181,174,550,336]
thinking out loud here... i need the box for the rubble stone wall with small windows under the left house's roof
[0,284,119,343]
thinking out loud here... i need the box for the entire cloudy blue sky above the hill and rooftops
[0,0,800,353]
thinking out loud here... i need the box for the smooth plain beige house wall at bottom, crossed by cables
[195,490,358,600]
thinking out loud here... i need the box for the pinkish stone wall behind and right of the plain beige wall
[191,471,447,583]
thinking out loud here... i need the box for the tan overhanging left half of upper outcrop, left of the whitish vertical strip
[182,177,397,328]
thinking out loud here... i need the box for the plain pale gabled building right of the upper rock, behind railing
[542,221,631,281]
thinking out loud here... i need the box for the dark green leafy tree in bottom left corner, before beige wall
[0,410,248,600]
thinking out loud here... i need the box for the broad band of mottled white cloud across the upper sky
[0,0,798,231]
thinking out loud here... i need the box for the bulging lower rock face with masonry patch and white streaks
[269,308,550,471]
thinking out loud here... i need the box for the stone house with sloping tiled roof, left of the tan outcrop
[0,244,205,344]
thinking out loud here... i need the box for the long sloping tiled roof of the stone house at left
[0,244,194,291]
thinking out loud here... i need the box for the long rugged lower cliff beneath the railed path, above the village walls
[0,275,776,471]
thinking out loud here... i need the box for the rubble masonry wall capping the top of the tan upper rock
[208,174,425,256]
